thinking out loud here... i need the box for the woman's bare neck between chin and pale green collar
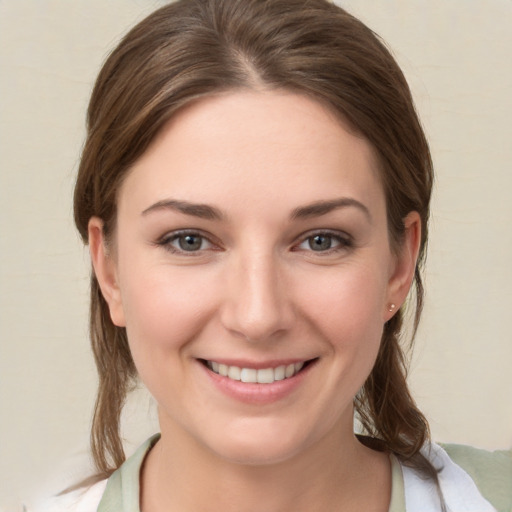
[141,418,391,512]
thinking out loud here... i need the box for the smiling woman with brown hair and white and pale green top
[51,0,510,512]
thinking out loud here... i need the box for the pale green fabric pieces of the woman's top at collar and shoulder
[98,434,512,512]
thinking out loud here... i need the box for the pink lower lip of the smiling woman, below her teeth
[199,362,315,405]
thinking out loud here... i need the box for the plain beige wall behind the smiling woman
[0,0,512,511]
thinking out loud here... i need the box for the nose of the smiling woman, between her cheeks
[221,249,294,342]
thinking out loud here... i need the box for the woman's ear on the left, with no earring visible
[88,217,126,327]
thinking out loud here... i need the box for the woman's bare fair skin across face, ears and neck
[89,91,420,512]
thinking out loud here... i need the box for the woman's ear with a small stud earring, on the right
[383,212,421,322]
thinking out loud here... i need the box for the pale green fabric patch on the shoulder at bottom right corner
[442,444,512,512]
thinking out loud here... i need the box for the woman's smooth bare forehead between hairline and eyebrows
[119,91,383,219]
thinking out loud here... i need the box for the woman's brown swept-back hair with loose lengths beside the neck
[74,0,435,478]
